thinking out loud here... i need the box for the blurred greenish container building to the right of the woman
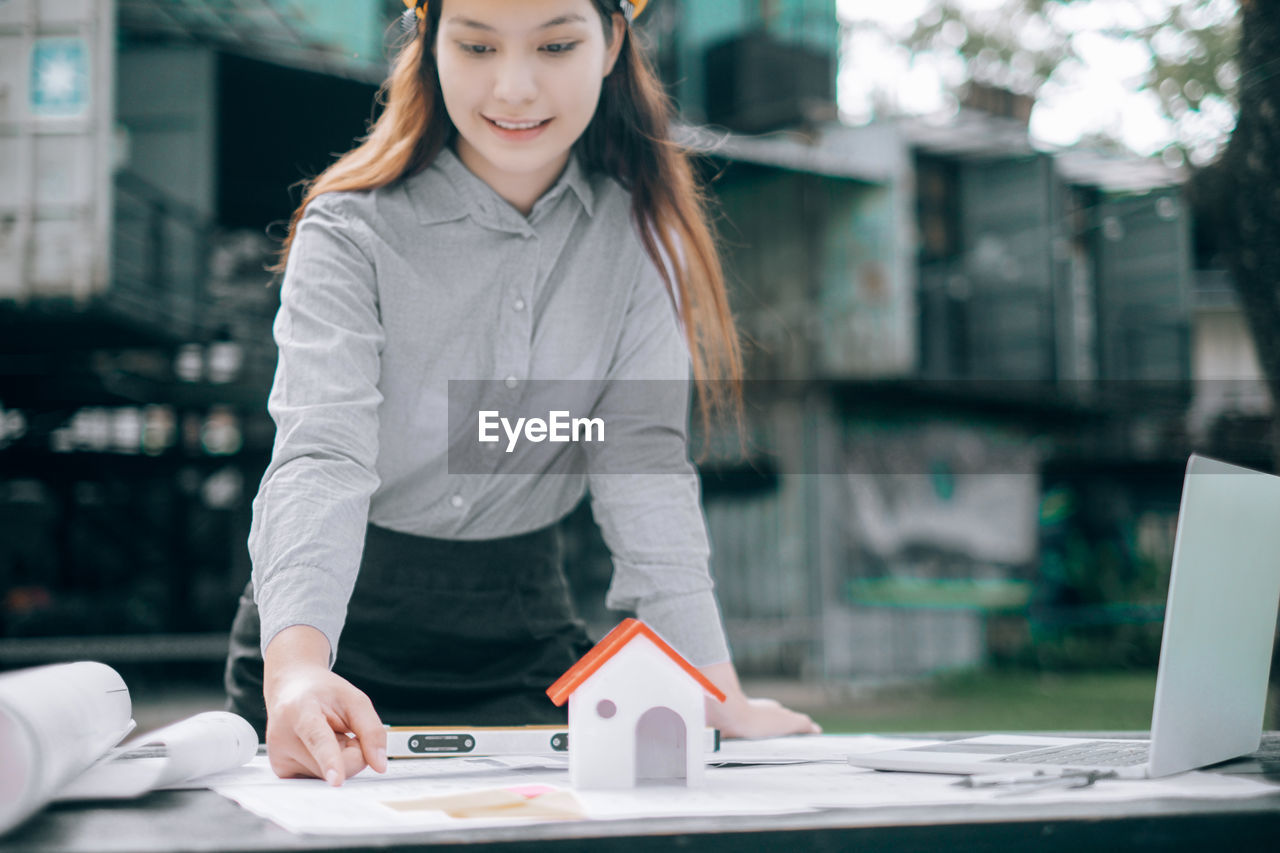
[614,0,1270,678]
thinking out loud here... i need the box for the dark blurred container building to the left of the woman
[0,0,402,666]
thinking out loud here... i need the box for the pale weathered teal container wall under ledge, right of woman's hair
[709,127,918,379]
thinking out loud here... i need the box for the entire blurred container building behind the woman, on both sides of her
[0,0,1268,679]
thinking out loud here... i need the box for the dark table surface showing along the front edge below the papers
[0,733,1280,853]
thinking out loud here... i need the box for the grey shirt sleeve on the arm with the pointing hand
[248,193,384,666]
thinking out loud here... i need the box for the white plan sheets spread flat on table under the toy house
[211,735,1280,835]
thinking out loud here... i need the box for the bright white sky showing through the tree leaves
[837,0,1235,161]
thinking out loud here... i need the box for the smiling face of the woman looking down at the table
[433,0,626,213]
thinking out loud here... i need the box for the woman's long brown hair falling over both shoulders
[269,0,742,427]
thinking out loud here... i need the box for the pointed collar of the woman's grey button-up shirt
[410,146,595,231]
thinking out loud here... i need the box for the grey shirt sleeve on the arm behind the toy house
[588,244,730,666]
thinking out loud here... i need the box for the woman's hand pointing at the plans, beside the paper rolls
[262,625,387,785]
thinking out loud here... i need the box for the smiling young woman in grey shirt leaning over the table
[227,0,818,785]
